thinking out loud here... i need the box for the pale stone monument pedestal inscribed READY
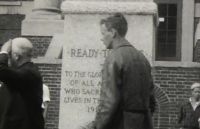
[59,1,157,129]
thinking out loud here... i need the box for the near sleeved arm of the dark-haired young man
[95,60,120,129]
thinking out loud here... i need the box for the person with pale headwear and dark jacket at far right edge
[178,82,200,129]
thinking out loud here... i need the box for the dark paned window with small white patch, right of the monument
[155,0,181,61]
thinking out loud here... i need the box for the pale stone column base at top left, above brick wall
[22,0,64,36]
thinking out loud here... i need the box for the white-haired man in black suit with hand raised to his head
[0,38,44,129]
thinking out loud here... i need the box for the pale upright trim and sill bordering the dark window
[152,0,195,67]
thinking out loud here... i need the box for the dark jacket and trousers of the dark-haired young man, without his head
[95,39,153,129]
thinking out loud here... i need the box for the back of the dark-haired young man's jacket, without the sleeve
[106,41,153,110]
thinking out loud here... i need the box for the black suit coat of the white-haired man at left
[0,53,44,129]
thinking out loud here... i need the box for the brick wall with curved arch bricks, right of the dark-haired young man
[153,67,200,129]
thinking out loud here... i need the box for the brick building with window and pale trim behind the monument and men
[0,0,200,129]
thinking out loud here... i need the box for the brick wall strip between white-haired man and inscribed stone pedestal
[38,64,61,129]
